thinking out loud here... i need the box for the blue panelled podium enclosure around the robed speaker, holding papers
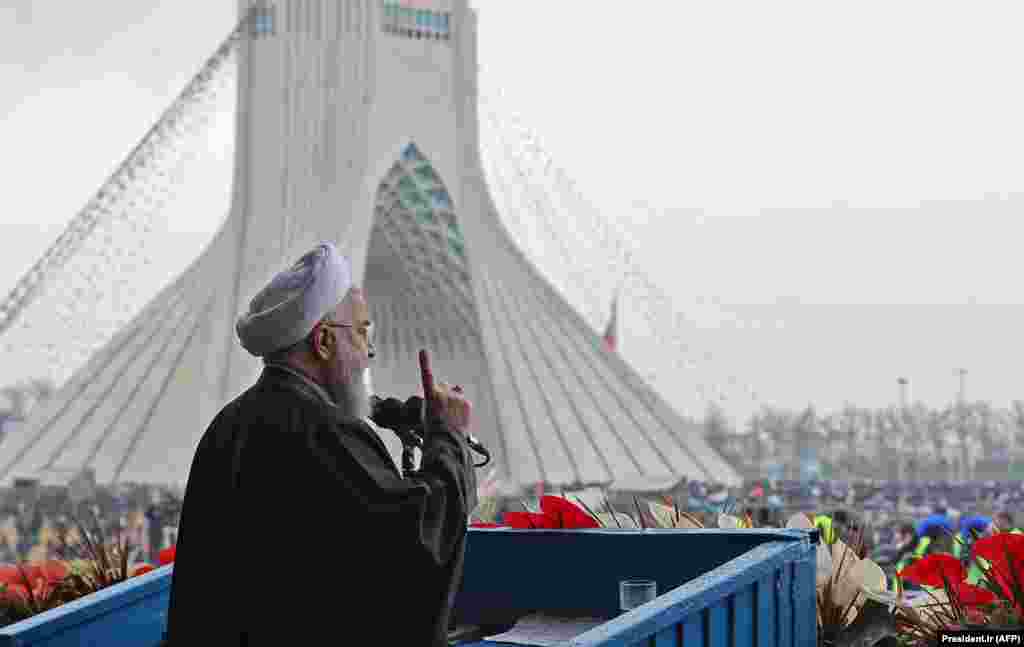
[0,528,818,647]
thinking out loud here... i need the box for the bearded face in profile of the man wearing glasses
[322,288,371,418]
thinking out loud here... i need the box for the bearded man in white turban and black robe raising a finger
[167,244,476,647]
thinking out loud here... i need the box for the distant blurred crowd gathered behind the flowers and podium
[0,480,1024,568]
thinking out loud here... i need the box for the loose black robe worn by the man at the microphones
[167,366,476,647]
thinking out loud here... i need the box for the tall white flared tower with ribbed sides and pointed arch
[0,0,738,495]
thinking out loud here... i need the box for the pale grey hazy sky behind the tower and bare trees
[0,0,1024,423]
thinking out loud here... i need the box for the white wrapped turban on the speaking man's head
[234,243,352,357]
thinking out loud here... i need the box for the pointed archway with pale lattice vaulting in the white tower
[364,143,488,397]
